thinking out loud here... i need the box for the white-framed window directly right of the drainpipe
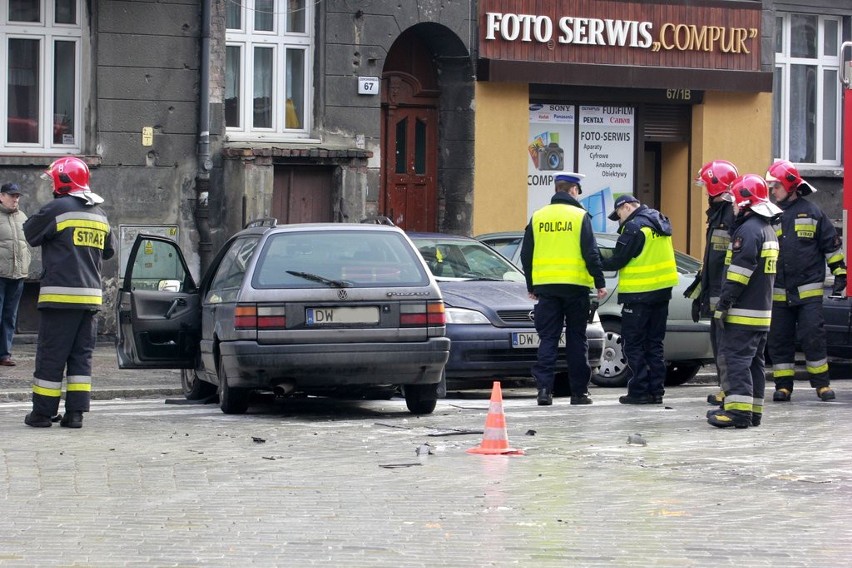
[225,0,313,139]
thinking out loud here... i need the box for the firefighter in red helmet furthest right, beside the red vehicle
[766,160,846,402]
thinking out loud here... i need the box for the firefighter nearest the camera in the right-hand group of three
[707,174,781,428]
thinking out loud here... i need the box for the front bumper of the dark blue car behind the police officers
[446,325,604,379]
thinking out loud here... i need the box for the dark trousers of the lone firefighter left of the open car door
[33,308,97,416]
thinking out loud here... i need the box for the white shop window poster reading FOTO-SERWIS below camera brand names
[576,106,636,232]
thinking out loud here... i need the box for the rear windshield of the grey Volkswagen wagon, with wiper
[252,230,429,289]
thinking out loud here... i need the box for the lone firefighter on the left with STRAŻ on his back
[24,156,115,428]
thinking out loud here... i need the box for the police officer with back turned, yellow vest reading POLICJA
[521,172,606,406]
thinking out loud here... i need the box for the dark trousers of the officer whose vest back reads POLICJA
[532,294,592,395]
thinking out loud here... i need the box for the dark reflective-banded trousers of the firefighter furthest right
[769,302,830,391]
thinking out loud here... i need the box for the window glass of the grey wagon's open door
[130,239,187,292]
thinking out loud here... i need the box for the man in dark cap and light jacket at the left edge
[0,183,30,367]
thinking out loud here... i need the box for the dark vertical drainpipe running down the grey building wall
[195,0,213,274]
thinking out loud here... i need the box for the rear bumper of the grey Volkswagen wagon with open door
[219,337,450,389]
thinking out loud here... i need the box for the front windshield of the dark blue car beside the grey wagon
[412,237,524,282]
